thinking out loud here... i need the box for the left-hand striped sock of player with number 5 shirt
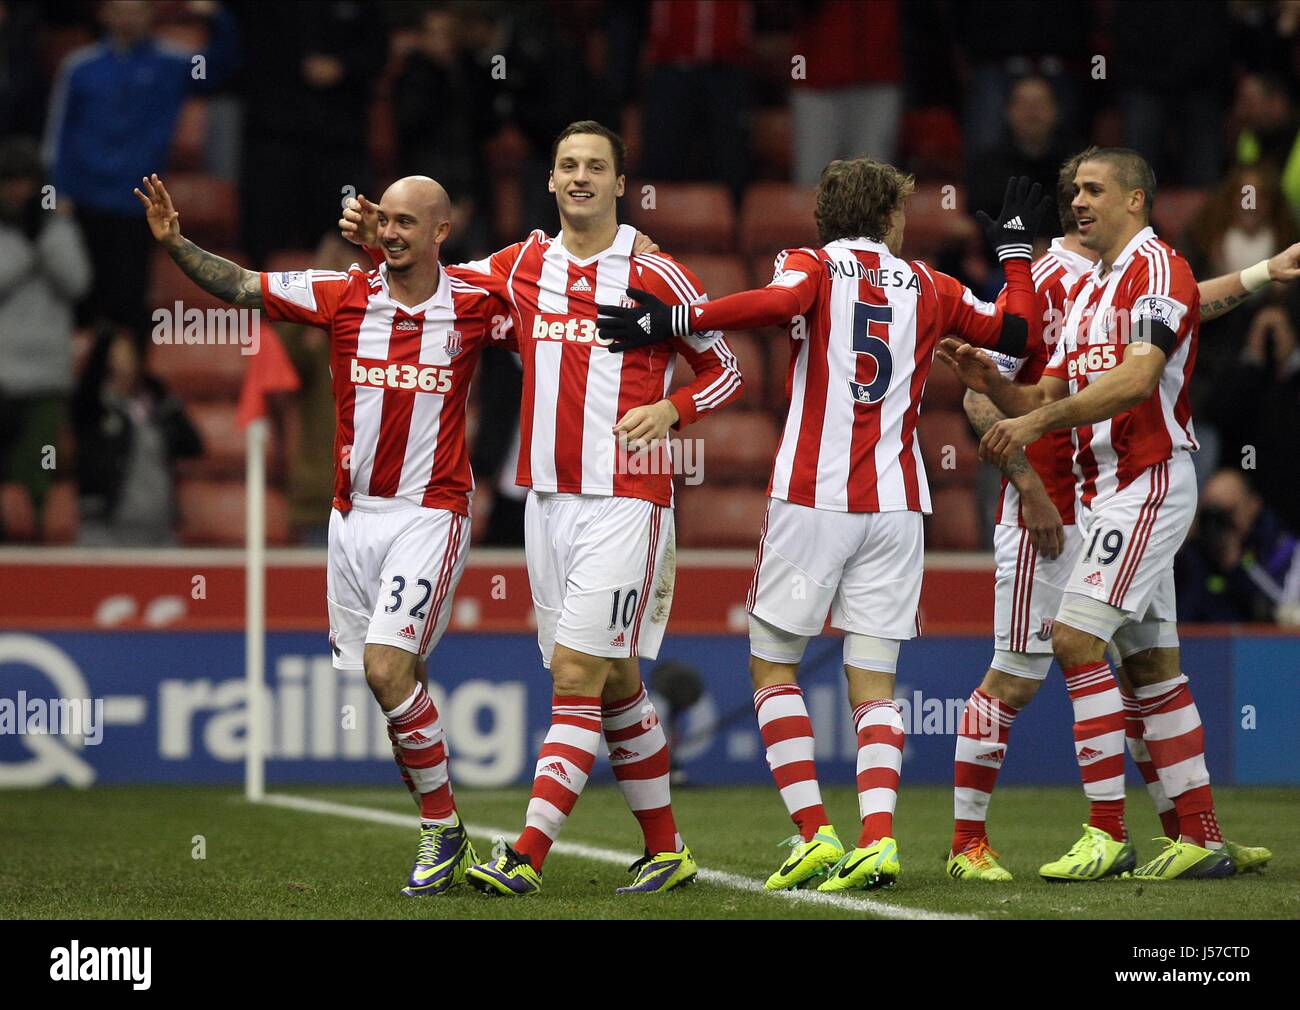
[754,684,831,841]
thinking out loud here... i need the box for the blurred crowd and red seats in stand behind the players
[0,0,1300,620]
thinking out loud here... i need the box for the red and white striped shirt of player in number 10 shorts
[464,225,741,506]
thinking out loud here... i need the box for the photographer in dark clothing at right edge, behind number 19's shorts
[1175,469,1300,624]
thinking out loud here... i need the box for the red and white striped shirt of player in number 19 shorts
[1044,227,1201,508]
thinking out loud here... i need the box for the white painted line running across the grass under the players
[263,793,980,919]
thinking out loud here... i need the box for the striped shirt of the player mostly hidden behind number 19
[993,238,1093,529]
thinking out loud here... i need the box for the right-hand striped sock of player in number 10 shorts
[601,684,681,855]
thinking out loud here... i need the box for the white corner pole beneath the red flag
[244,417,268,803]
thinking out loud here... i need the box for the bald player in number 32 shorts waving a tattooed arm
[135,168,507,896]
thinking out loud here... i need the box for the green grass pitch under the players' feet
[0,785,1300,919]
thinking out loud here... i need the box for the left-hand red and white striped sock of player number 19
[1065,659,1128,841]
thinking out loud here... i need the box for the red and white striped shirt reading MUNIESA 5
[707,238,1032,513]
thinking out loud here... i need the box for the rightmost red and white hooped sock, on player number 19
[1134,675,1223,849]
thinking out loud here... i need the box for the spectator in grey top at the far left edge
[0,138,91,536]
